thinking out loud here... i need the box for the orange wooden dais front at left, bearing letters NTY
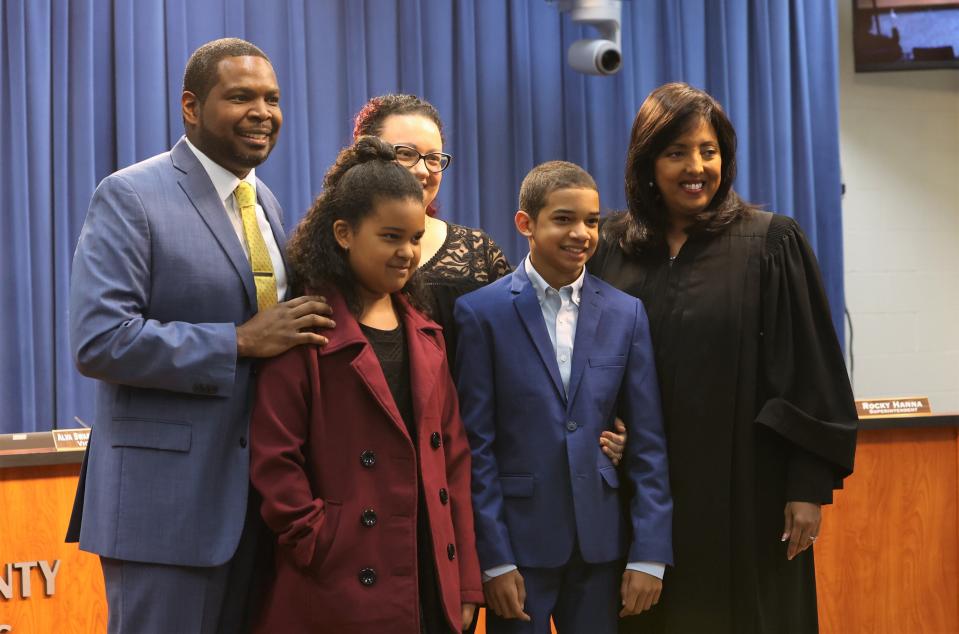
[0,464,107,634]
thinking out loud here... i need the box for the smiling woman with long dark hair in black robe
[589,83,856,634]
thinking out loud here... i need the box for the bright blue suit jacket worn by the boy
[455,266,672,570]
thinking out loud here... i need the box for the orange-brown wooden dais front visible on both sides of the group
[0,428,959,634]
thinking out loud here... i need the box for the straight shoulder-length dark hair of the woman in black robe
[604,82,752,253]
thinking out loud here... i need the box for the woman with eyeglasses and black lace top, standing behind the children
[353,94,510,367]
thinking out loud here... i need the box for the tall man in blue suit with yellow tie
[68,39,331,634]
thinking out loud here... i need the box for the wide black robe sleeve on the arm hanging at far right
[756,216,857,503]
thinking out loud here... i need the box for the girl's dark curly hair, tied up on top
[287,136,426,316]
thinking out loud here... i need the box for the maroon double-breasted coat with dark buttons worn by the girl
[250,292,483,634]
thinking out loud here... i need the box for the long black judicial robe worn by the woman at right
[589,211,856,634]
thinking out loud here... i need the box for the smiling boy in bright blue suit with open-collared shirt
[455,161,672,634]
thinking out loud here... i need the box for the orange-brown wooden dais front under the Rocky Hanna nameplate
[816,428,959,634]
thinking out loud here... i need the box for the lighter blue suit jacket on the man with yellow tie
[67,139,286,566]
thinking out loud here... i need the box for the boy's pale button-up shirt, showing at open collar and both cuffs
[483,256,666,581]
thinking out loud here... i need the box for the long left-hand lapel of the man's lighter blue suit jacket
[170,139,256,310]
